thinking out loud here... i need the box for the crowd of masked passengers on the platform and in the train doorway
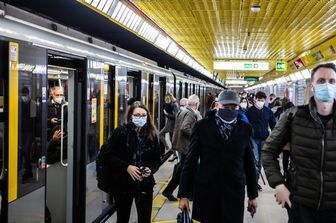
[42,63,336,223]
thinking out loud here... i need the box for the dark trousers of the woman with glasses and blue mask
[113,191,153,223]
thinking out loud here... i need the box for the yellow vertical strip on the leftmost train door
[8,42,19,202]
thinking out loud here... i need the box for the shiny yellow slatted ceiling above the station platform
[130,0,336,77]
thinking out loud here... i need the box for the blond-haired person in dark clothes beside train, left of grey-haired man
[159,93,178,152]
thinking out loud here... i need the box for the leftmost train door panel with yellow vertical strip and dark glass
[8,43,47,222]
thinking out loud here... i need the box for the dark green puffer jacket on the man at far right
[261,97,336,210]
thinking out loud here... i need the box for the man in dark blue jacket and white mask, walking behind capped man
[245,91,276,190]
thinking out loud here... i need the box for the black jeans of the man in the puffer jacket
[288,201,336,223]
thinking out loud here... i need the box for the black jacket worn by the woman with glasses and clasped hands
[108,123,161,192]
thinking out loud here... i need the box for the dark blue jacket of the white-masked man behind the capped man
[245,106,276,140]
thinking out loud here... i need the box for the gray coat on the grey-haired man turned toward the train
[172,108,202,154]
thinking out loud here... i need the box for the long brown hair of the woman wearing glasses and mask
[126,101,157,141]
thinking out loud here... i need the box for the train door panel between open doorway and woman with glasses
[85,60,110,222]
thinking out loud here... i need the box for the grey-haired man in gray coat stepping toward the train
[162,95,202,201]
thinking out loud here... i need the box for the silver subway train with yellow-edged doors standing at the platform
[0,3,221,223]
